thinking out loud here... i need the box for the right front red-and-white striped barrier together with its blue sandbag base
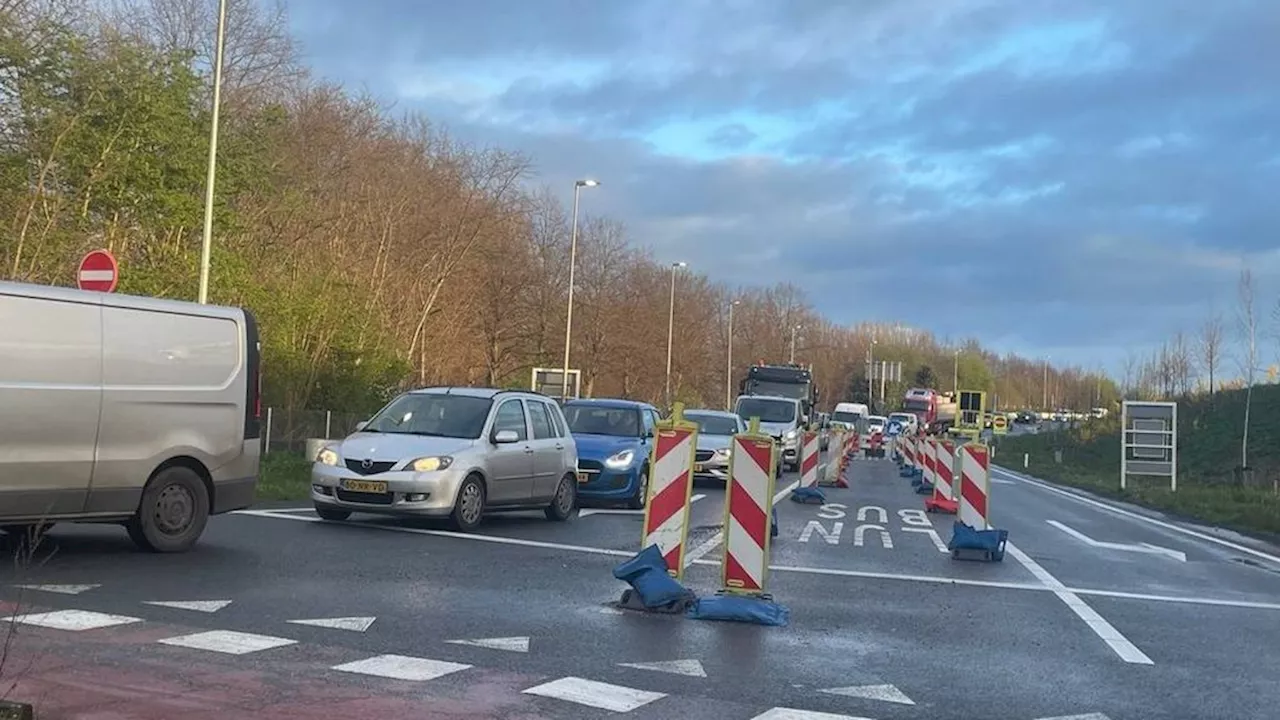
[689,418,790,625]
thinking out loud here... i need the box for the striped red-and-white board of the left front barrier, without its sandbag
[640,404,698,579]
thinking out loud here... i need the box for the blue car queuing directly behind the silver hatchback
[563,400,659,510]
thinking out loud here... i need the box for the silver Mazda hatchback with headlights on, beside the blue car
[311,387,577,530]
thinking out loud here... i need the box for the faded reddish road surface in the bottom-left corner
[0,623,548,720]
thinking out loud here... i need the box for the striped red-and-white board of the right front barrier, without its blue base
[721,423,777,596]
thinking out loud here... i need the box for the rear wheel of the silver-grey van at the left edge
[125,465,209,552]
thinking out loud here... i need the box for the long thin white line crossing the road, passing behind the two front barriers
[233,510,1280,615]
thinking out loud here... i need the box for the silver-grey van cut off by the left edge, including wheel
[0,282,261,552]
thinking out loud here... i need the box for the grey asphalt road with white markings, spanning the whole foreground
[0,448,1280,720]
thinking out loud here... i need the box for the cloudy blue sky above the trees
[292,0,1280,374]
